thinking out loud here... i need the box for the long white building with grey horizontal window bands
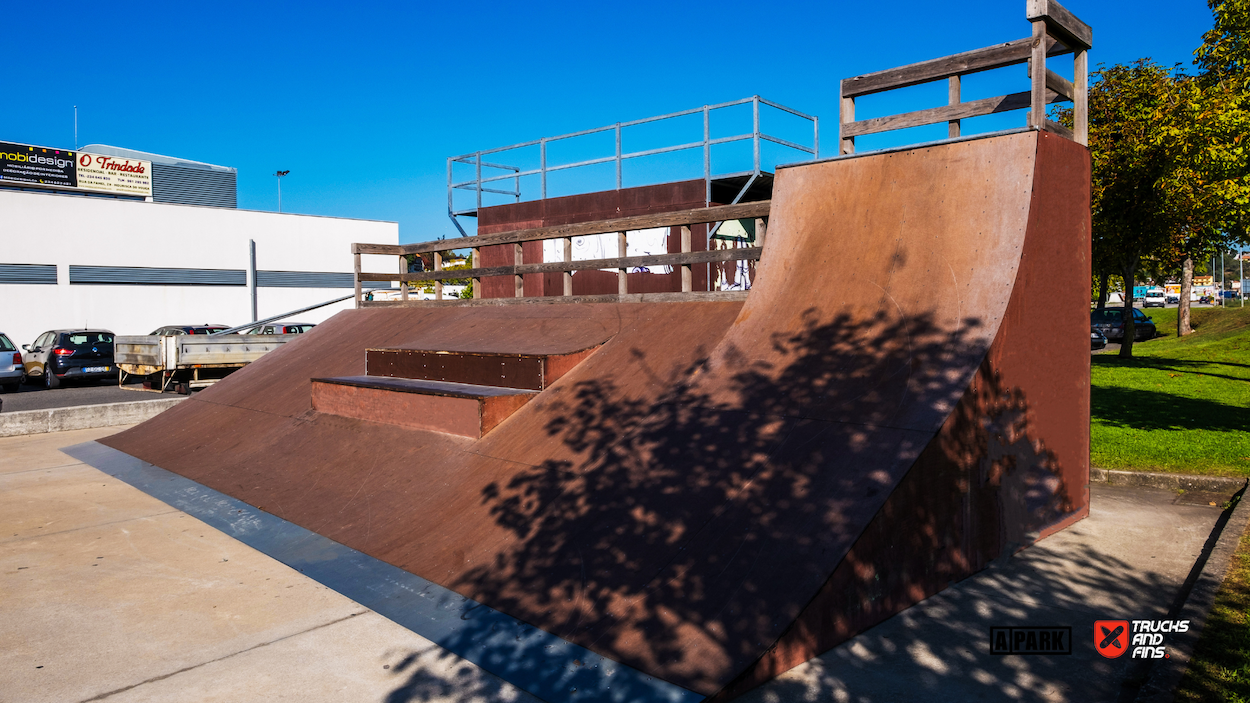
[0,157,399,345]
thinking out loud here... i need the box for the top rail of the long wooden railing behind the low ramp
[390,200,770,254]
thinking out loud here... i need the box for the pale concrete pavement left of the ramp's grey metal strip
[0,428,534,703]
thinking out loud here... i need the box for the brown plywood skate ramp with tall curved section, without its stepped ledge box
[108,133,1089,697]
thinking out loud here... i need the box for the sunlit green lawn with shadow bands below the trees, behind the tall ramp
[1090,308,1250,475]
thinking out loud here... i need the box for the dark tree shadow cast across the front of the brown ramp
[382,310,1085,700]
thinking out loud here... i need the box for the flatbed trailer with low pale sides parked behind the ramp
[113,334,300,395]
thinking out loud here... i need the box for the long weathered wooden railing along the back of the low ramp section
[351,200,770,308]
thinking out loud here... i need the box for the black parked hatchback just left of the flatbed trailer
[21,329,118,388]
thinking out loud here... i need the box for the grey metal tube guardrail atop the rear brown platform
[448,95,820,236]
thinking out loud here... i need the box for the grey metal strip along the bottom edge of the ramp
[61,442,704,703]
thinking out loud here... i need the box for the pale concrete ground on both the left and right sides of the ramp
[0,428,1220,703]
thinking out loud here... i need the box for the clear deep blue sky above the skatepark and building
[7,0,1211,241]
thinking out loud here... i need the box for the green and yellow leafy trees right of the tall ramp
[1060,0,1250,357]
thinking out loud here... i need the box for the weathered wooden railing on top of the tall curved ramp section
[840,0,1094,154]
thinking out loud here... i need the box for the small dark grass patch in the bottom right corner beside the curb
[1176,507,1250,703]
